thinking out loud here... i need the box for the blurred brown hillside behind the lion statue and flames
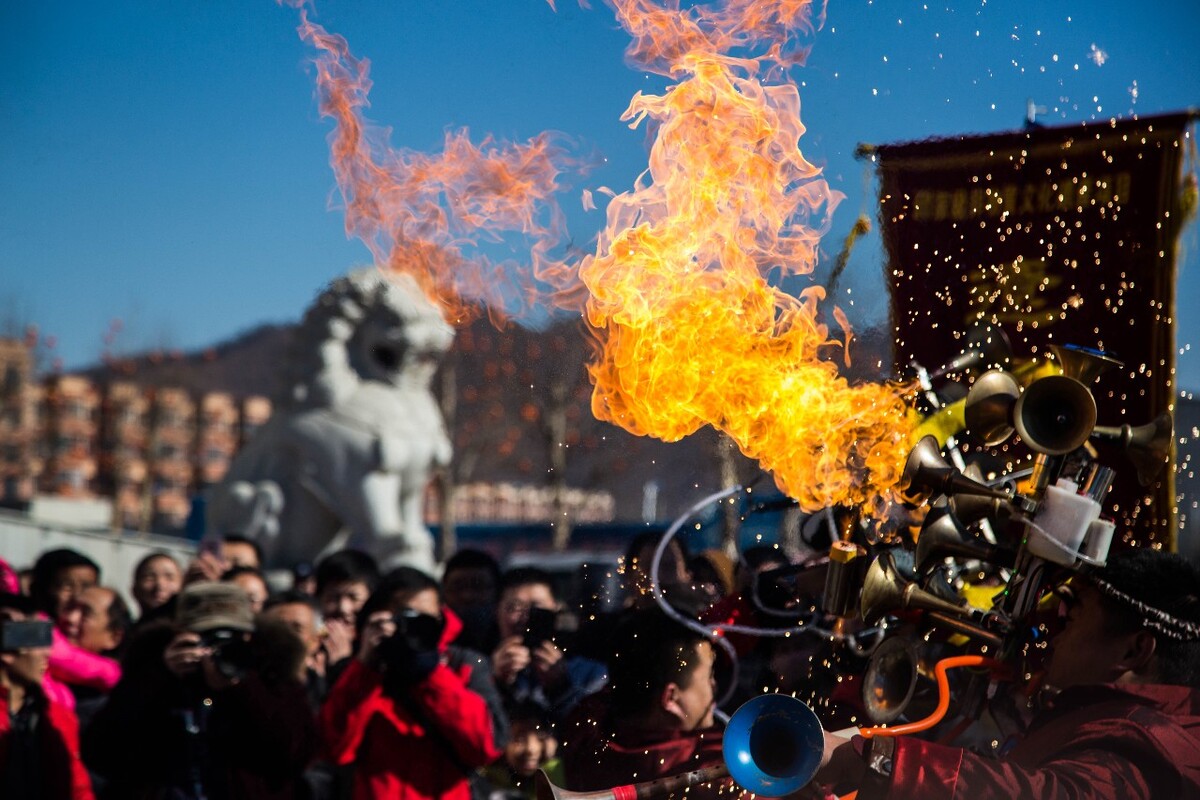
[77,309,902,521]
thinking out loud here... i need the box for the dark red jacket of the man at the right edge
[873,685,1200,800]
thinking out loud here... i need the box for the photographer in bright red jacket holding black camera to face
[320,567,508,800]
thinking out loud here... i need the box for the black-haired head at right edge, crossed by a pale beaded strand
[1046,548,1200,688]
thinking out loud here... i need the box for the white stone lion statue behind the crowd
[206,267,454,571]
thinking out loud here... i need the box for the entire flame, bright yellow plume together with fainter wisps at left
[282,0,910,510]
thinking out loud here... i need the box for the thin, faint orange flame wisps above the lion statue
[288,0,582,323]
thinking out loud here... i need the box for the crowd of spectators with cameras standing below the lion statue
[0,536,758,800]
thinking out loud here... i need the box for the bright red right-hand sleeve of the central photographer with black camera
[410,663,500,766]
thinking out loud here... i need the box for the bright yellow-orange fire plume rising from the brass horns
[580,0,908,510]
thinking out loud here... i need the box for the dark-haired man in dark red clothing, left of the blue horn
[560,608,733,800]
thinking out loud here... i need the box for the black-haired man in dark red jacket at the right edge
[812,549,1200,800]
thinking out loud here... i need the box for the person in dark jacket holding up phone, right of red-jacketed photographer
[492,567,607,723]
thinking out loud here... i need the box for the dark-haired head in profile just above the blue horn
[608,609,716,730]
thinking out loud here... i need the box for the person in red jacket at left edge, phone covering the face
[0,594,92,800]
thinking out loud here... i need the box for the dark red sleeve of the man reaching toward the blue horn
[873,720,1177,800]
